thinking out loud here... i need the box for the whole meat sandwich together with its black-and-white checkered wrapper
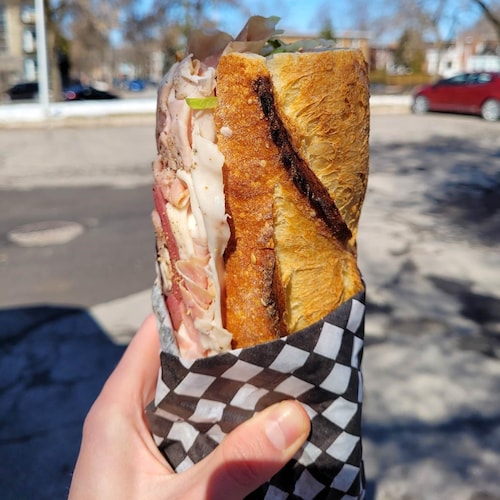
[147,17,369,498]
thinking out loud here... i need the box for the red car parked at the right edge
[412,71,500,122]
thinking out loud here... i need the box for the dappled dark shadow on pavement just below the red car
[371,135,500,246]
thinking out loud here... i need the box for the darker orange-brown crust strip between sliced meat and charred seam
[215,52,288,347]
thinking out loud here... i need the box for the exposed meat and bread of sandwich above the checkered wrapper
[152,16,369,359]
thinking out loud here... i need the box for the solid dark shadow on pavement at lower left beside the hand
[0,306,124,500]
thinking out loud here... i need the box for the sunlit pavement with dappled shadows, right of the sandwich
[359,114,500,500]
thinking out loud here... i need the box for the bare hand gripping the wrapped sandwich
[69,316,310,500]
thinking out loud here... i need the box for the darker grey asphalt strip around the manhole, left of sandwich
[0,186,155,307]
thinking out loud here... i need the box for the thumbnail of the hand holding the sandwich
[265,401,309,451]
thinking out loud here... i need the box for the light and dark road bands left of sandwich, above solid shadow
[0,119,155,307]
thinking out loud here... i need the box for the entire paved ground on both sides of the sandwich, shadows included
[0,113,500,500]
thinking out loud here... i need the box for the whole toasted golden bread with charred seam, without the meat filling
[215,50,369,347]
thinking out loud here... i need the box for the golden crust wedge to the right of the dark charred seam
[267,50,370,246]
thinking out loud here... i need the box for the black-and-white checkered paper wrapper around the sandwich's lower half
[147,285,365,500]
